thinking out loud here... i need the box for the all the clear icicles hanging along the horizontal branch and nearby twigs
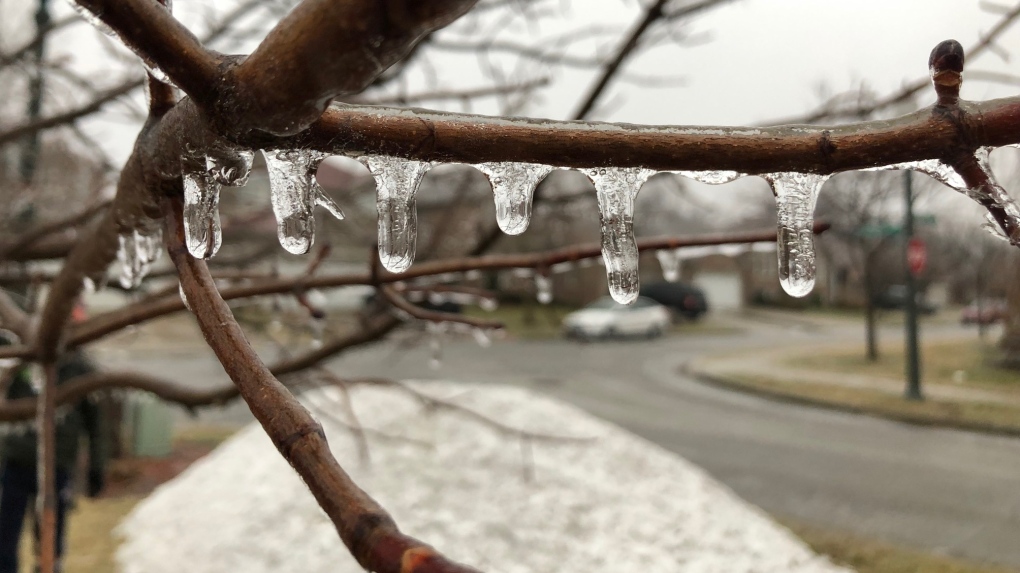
[111,144,1020,304]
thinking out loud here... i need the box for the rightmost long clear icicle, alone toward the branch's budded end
[762,172,828,297]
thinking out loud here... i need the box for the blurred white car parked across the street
[563,297,672,340]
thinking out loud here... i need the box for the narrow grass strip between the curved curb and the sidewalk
[726,374,1020,435]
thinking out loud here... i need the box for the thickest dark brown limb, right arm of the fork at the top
[223,0,476,134]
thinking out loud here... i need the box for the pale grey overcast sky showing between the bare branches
[7,0,1020,223]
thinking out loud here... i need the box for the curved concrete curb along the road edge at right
[679,362,1020,437]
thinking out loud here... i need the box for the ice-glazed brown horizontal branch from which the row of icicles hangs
[245,97,1020,174]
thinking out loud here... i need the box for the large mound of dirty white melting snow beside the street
[118,383,844,573]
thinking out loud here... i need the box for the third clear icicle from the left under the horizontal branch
[362,156,431,272]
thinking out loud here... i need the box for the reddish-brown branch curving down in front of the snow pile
[163,194,483,573]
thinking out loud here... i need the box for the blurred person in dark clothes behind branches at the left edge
[0,330,108,573]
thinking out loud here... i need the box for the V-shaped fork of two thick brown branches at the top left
[75,0,476,135]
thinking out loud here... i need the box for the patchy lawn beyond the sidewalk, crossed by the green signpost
[786,341,1020,392]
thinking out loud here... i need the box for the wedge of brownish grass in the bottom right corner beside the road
[779,519,1017,573]
